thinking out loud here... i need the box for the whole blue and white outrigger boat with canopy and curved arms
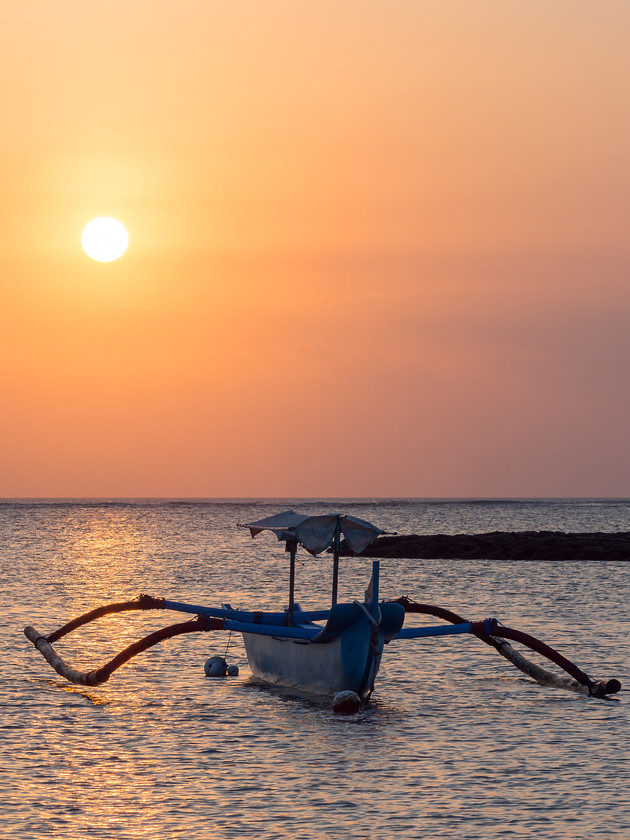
[24,510,621,713]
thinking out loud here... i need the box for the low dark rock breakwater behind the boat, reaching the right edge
[341,531,630,561]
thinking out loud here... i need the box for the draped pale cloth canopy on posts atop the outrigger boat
[241,510,384,555]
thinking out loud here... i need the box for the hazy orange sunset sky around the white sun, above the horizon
[0,0,630,497]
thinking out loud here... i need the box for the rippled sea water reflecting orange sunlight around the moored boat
[0,500,630,840]
